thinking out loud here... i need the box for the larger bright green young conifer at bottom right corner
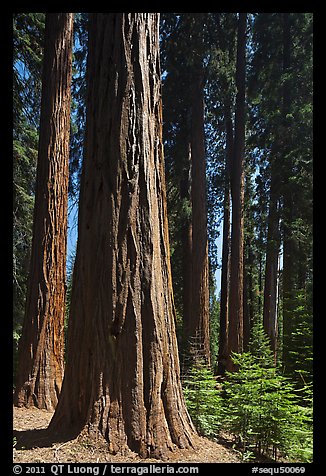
[224,325,312,462]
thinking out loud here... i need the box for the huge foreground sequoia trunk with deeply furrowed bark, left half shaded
[50,13,195,457]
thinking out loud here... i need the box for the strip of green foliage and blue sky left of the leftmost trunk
[13,13,44,378]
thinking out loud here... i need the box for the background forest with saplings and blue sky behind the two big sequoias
[13,13,313,462]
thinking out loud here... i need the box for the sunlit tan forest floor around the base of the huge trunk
[13,408,241,464]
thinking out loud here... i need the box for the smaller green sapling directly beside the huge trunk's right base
[183,360,223,437]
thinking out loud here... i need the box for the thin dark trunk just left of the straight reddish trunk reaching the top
[217,103,233,375]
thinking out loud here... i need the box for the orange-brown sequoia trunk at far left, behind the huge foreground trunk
[14,13,73,410]
